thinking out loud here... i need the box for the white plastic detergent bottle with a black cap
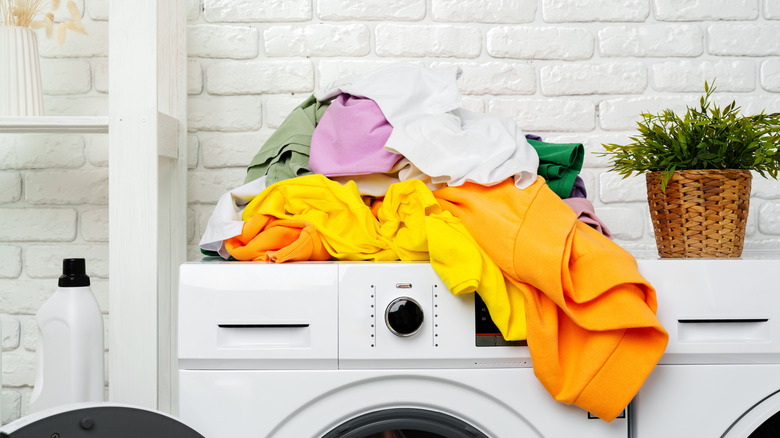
[30,259,104,412]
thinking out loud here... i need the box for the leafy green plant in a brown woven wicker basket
[601,82,780,258]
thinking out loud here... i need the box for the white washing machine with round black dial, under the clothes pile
[178,261,628,438]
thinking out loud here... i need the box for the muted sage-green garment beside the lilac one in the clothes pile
[244,95,330,186]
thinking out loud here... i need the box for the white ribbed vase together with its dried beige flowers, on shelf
[0,0,86,116]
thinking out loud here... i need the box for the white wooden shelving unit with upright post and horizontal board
[0,0,187,413]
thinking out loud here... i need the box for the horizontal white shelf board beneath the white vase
[0,116,108,134]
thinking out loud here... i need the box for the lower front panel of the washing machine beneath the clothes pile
[179,368,627,438]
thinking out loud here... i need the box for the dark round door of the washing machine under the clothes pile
[323,408,488,438]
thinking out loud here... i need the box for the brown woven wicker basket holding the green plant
[646,169,752,258]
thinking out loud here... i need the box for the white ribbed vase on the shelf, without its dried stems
[0,26,43,117]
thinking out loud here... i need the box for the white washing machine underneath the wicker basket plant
[630,255,780,438]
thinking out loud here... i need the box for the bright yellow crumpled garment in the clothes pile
[239,174,512,314]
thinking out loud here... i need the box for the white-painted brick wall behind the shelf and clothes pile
[0,0,780,421]
